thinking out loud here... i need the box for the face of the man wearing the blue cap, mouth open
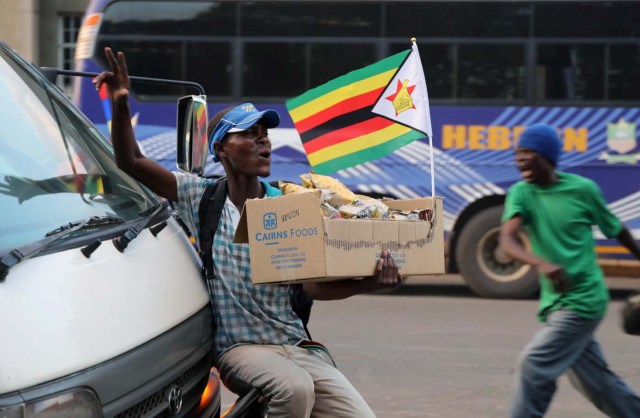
[222,122,271,177]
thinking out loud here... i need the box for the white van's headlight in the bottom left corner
[0,389,102,418]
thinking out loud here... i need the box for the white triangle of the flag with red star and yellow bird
[372,43,433,138]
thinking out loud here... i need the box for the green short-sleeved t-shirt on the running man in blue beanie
[502,172,622,321]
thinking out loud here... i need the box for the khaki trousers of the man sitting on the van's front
[219,344,375,418]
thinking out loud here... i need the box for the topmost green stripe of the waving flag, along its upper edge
[286,50,411,111]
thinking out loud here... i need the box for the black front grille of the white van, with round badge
[115,356,211,418]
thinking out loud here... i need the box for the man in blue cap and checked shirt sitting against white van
[94,48,402,418]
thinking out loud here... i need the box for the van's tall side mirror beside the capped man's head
[176,96,209,175]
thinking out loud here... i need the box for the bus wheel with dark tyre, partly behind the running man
[456,206,538,298]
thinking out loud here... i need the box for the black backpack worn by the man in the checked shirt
[198,177,313,340]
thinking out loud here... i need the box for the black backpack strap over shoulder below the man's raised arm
[198,177,227,280]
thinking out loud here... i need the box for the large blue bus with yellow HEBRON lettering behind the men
[74,0,640,298]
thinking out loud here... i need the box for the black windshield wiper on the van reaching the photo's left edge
[0,216,124,283]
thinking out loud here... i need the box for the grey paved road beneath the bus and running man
[218,276,640,418]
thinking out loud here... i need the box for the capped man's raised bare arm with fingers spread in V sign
[94,48,178,201]
